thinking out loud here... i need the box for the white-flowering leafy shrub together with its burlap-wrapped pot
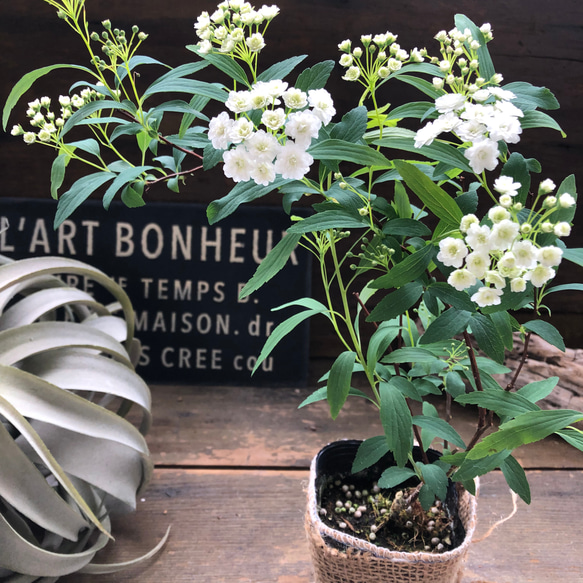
[4,0,583,582]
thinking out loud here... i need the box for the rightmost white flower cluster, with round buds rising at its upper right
[437,176,575,307]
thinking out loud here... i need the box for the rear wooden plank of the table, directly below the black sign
[148,385,583,468]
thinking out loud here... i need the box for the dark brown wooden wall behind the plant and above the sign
[0,0,583,356]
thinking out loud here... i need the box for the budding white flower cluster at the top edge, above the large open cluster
[194,0,279,54]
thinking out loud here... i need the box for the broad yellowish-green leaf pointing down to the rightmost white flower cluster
[395,160,463,229]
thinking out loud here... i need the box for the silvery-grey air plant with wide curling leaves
[0,251,165,581]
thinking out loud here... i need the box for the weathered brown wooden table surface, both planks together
[62,386,583,583]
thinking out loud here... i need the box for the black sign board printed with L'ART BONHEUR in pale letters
[0,198,310,386]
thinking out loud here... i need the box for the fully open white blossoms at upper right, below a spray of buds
[415,86,524,174]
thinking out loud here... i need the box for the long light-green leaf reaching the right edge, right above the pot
[468,409,583,459]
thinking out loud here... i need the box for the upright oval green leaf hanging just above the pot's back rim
[379,383,413,468]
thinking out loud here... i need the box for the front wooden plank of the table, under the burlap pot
[62,470,583,583]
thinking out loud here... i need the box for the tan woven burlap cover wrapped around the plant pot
[306,442,476,583]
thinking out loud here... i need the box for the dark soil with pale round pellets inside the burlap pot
[319,475,464,553]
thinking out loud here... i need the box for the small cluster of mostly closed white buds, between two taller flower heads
[338,31,427,82]
